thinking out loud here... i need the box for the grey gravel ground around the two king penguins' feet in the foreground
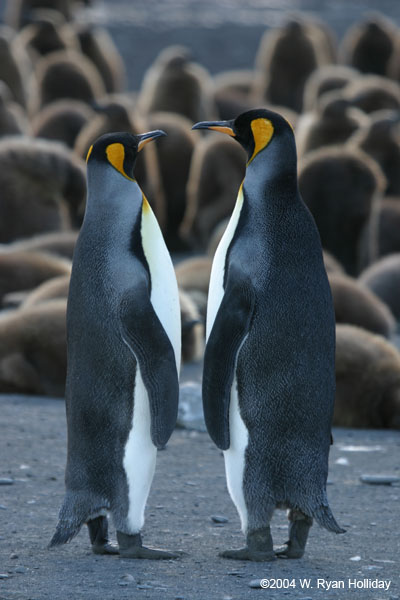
[0,384,400,600]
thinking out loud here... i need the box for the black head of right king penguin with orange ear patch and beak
[192,108,294,164]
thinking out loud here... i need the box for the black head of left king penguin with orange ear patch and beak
[86,129,167,181]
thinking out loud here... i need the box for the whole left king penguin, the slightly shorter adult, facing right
[50,130,181,559]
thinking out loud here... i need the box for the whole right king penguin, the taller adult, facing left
[194,109,343,561]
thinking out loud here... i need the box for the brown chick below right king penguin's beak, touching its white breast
[181,134,246,249]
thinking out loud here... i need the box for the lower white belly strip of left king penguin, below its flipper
[123,365,157,534]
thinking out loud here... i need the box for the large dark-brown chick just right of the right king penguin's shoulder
[299,146,386,275]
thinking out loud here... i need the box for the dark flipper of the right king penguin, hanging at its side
[203,265,255,450]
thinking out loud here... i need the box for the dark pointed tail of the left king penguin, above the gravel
[48,491,108,548]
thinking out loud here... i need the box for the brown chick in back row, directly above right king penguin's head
[255,20,330,112]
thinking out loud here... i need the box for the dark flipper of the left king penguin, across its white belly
[120,284,179,448]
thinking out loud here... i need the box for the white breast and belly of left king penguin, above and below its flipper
[123,201,181,534]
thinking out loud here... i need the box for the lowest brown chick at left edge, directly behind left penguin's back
[0,300,67,397]
